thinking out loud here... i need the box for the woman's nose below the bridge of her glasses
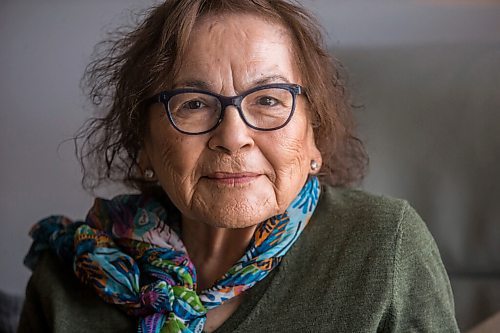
[208,106,254,154]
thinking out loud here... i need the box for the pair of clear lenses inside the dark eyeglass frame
[168,88,293,133]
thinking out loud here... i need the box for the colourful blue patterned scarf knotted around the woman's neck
[25,177,320,333]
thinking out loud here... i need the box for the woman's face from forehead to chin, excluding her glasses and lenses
[141,14,321,228]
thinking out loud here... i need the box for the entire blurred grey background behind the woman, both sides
[0,0,500,330]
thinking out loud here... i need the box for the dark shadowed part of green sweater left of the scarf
[19,252,136,332]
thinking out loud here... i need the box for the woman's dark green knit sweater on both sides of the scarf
[19,186,458,333]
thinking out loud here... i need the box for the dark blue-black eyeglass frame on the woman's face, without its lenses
[145,83,304,135]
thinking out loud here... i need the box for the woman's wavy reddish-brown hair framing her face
[75,0,368,191]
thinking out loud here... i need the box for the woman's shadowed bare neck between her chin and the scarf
[182,217,257,291]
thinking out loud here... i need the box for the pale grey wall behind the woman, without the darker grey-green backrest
[0,0,500,294]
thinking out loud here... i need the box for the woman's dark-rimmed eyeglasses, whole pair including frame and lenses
[146,83,303,135]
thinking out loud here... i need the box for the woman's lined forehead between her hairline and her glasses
[174,14,300,87]
